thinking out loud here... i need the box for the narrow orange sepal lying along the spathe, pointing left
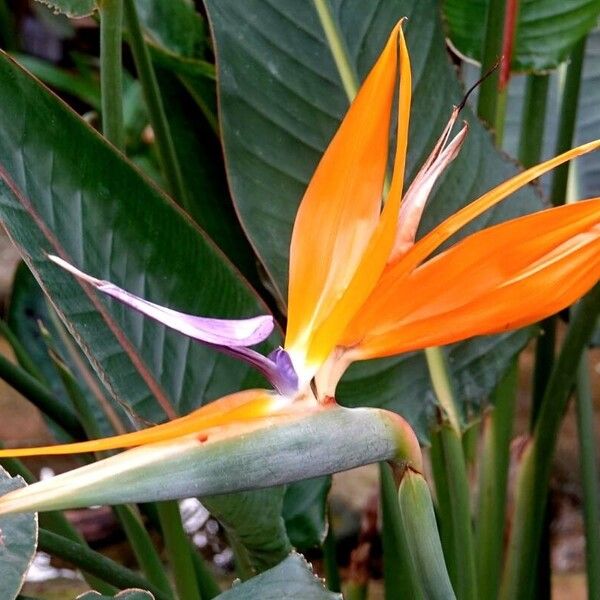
[0,390,281,458]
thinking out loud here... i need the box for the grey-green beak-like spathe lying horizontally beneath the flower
[0,406,421,514]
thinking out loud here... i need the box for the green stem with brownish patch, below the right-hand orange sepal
[475,361,518,599]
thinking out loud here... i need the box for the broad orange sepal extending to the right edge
[345,199,600,358]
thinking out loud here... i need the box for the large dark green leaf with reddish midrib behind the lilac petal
[0,50,285,568]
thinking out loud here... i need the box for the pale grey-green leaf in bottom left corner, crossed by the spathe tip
[0,467,38,600]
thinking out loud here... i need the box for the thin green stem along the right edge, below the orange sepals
[576,352,600,598]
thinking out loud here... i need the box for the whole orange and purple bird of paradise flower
[0,24,600,512]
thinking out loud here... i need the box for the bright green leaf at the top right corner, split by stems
[444,0,600,71]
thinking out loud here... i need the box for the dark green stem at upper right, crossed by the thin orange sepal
[550,36,587,206]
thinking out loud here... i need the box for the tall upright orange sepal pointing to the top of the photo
[286,25,411,372]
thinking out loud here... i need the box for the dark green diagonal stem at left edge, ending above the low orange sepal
[0,355,85,440]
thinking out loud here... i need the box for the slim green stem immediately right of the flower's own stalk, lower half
[440,425,478,600]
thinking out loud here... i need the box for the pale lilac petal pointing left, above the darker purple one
[48,255,274,346]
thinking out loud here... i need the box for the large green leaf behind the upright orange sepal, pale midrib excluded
[206,0,541,438]
